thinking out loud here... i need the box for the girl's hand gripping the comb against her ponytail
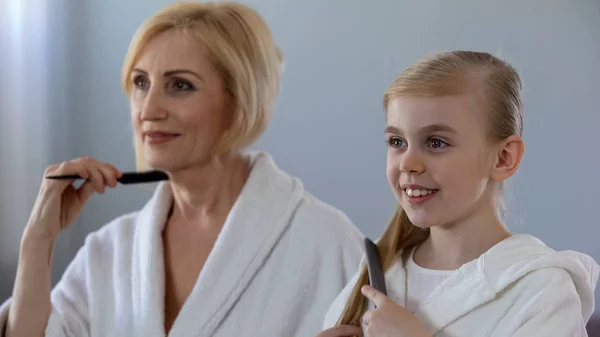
[361,286,432,337]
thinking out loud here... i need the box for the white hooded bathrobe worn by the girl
[323,235,599,337]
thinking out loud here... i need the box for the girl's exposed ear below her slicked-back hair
[491,135,525,181]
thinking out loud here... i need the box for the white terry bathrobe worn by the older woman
[0,152,362,337]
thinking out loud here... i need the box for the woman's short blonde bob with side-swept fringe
[121,2,283,169]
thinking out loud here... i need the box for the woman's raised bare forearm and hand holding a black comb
[7,158,122,337]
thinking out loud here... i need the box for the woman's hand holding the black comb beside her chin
[25,158,122,240]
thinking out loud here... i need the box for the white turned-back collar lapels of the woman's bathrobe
[132,152,303,337]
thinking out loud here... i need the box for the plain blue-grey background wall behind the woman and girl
[0,0,600,316]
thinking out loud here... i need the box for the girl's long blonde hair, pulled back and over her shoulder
[338,51,523,326]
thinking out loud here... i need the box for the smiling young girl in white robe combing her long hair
[319,51,599,337]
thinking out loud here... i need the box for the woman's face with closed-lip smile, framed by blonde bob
[130,29,233,172]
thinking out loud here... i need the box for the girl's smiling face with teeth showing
[385,93,503,228]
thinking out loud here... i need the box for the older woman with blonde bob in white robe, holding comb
[0,3,362,337]
